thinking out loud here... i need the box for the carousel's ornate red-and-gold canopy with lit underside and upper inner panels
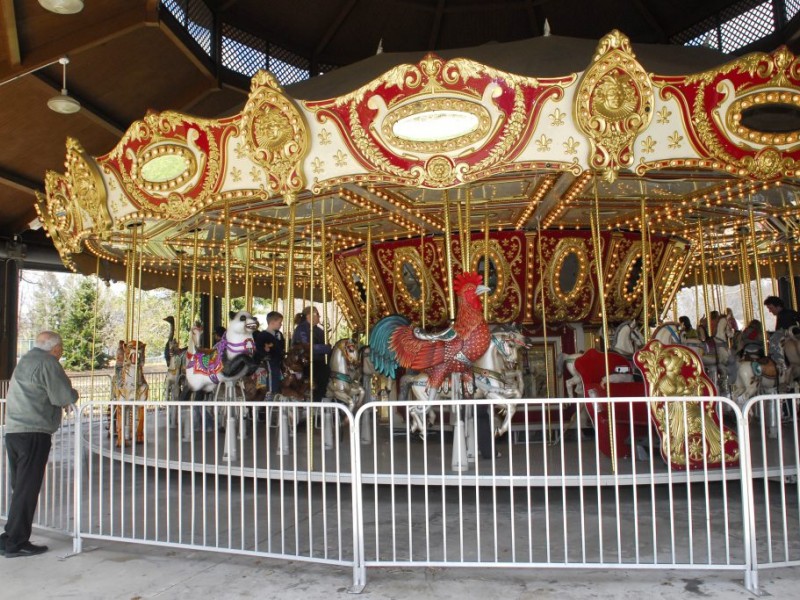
[32,25,800,322]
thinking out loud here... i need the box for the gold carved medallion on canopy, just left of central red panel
[242,71,310,204]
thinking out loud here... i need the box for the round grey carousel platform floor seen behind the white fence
[84,408,798,487]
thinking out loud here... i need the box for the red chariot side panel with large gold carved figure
[636,340,739,468]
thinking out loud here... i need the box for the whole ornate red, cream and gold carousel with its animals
[37,31,800,480]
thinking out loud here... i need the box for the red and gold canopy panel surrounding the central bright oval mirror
[304,54,574,188]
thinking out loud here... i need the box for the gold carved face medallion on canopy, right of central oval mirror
[575,30,654,181]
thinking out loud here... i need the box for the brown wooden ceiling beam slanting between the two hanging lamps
[0,7,146,82]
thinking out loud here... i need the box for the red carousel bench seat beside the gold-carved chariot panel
[575,349,650,458]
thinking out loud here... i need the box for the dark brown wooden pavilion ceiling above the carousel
[0,0,797,249]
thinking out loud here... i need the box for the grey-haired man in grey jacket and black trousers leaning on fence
[0,331,78,558]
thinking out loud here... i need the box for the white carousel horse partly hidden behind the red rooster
[400,328,526,435]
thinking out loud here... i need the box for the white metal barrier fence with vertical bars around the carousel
[0,396,800,589]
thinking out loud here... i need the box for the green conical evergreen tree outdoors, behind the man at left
[60,277,110,371]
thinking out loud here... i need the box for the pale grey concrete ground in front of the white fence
[0,531,800,600]
